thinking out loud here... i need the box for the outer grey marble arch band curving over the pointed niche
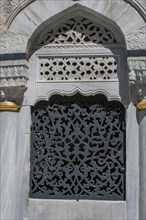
[8,0,145,51]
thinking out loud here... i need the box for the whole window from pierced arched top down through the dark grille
[30,12,125,200]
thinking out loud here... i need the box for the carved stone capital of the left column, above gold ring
[0,60,29,105]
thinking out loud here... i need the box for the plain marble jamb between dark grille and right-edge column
[126,103,139,220]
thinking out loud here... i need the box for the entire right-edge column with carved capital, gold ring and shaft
[129,57,146,220]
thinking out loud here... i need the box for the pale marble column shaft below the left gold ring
[0,112,18,220]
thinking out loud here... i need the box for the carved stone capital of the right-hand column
[128,57,146,109]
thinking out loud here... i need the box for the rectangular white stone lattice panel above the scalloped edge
[39,57,117,81]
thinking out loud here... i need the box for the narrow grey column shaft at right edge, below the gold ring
[139,109,146,220]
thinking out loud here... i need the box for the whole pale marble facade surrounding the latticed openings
[0,0,146,220]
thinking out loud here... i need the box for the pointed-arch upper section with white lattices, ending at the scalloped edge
[27,4,129,105]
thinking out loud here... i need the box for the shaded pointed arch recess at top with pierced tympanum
[27,4,126,55]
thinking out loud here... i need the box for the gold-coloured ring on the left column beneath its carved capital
[0,101,21,112]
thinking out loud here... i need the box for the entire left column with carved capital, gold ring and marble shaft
[0,57,28,220]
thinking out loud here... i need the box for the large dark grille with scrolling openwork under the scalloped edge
[30,94,125,200]
